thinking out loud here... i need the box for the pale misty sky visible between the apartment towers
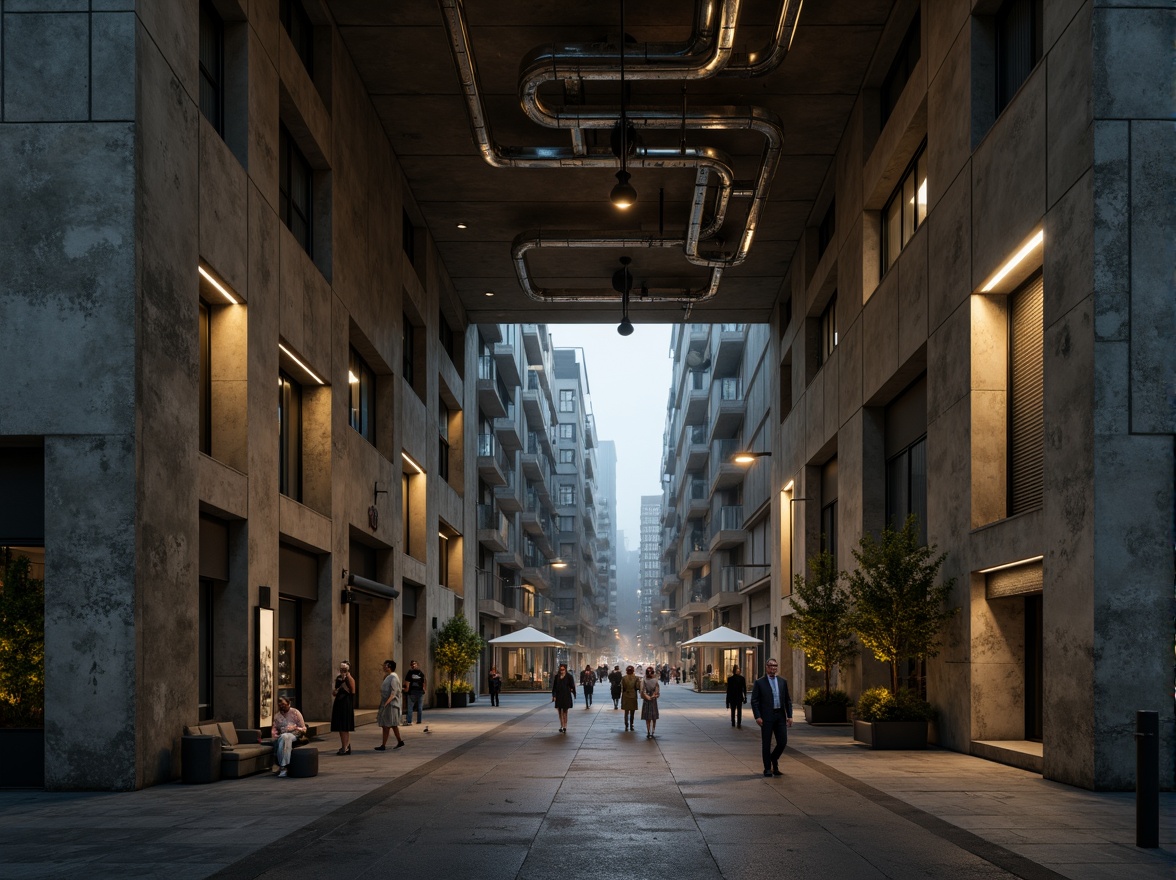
[547,324,673,549]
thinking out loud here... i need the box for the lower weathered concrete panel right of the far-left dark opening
[45,435,137,789]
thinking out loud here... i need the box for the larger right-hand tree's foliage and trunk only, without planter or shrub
[849,514,955,694]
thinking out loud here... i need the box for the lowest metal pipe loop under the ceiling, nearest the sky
[510,232,723,302]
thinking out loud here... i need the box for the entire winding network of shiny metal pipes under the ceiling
[439,0,800,304]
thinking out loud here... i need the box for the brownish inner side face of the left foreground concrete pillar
[134,20,199,785]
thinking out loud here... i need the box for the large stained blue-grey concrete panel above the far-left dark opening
[0,124,134,434]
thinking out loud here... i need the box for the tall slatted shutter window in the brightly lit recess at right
[1008,273,1044,516]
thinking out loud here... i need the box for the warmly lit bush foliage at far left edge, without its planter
[0,547,45,727]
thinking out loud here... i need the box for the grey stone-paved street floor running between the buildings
[0,685,1176,880]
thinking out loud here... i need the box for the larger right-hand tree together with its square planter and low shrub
[849,515,955,748]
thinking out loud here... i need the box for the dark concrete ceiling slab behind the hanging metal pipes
[327,0,893,324]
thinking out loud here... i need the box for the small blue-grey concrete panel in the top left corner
[2,10,91,122]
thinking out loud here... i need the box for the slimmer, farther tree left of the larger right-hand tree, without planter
[788,551,857,700]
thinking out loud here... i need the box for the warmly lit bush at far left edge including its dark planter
[0,547,45,788]
